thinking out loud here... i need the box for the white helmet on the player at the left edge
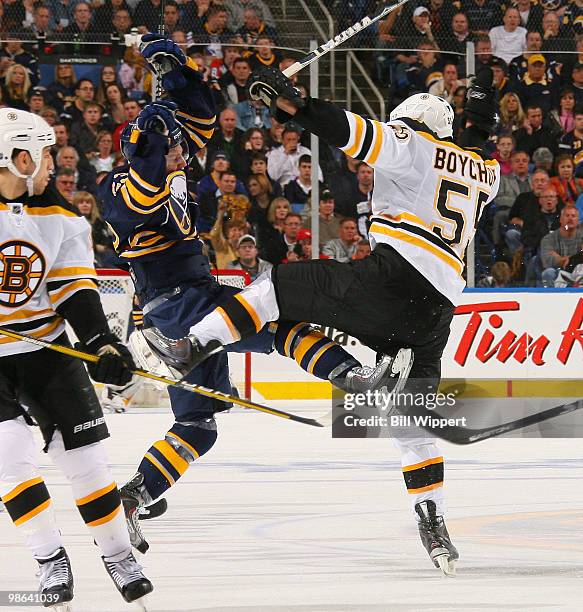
[0,108,55,195]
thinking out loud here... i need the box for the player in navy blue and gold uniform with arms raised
[101,34,402,552]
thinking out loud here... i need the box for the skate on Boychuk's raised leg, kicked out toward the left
[142,327,223,376]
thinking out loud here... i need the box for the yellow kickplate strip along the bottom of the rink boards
[252,379,583,400]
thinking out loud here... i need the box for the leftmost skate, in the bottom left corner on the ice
[36,547,73,612]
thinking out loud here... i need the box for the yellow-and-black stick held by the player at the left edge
[0,327,324,427]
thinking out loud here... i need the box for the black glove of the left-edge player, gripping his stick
[75,332,136,387]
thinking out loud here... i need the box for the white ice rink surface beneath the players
[0,402,583,612]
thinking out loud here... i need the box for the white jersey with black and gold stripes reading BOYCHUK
[341,112,500,305]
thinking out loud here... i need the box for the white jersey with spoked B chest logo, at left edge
[0,196,97,357]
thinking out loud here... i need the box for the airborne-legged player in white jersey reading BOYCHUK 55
[150,67,500,575]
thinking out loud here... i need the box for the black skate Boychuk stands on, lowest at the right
[415,500,459,578]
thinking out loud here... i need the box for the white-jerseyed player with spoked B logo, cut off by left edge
[0,108,152,610]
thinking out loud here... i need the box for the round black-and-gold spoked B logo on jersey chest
[0,240,46,308]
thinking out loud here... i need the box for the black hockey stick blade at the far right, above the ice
[424,399,583,445]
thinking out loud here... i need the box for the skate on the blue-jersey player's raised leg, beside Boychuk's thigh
[330,348,413,394]
